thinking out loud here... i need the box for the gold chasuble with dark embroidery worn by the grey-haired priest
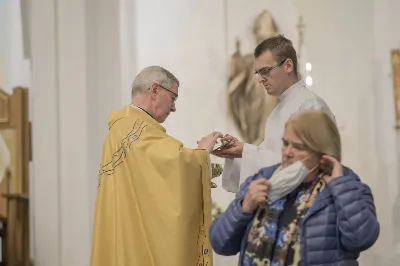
[91,106,212,266]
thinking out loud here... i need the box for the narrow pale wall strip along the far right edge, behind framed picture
[373,0,400,265]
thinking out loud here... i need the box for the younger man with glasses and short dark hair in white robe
[213,35,335,192]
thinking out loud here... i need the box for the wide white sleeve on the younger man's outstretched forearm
[222,143,281,192]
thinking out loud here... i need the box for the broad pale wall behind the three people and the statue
[137,0,400,265]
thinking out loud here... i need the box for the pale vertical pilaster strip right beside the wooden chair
[30,0,61,266]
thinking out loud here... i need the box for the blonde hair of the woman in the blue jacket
[286,110,342,162]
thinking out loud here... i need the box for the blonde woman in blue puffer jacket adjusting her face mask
[210,111,379,266]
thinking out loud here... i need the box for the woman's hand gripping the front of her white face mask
[242,178,271,213]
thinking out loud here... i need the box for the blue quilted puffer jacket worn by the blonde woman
[210,165,379,266]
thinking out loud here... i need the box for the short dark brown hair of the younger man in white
[254,34,297,76]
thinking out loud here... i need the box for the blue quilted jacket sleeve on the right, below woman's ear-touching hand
[328,175,380,252]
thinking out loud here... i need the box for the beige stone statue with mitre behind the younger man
[228,10,278,145]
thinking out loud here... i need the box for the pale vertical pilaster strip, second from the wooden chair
[56,0,91,266]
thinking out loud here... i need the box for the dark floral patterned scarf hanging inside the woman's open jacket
[242,178,325,266]
